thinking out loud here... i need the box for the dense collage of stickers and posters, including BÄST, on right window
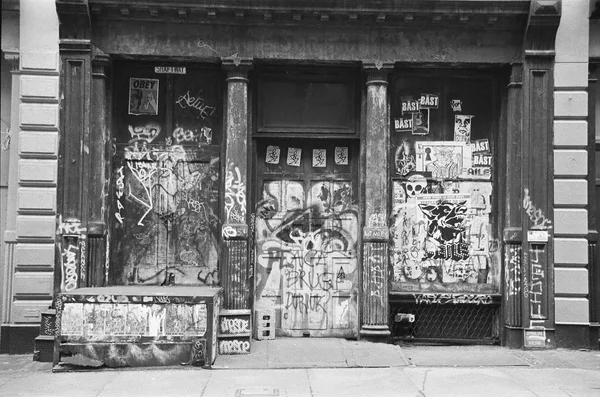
[391,93,493,290]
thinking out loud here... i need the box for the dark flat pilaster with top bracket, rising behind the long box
[55,0,92,292]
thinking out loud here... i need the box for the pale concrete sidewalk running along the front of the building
[0,338,600,397]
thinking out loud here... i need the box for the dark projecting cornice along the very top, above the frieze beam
[85,0,530,29]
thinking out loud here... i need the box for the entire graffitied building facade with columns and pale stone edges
[1,0,600,362]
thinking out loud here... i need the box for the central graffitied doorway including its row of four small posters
[254,140,359,337]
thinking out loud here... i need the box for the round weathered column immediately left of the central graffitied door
[220,57,252,309]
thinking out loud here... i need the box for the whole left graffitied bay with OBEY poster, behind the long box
[107,64,223,286]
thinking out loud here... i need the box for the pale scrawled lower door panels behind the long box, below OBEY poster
[114,145,219,285]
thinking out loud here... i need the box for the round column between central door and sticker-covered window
[360,62,393,341]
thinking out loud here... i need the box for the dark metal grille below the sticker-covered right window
[390,303,500,344]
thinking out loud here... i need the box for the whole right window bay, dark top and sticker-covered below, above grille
[390,72,500,293]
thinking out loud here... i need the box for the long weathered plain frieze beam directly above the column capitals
[93,19,523,64]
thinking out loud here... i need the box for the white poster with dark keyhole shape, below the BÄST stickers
[415,141,471,179]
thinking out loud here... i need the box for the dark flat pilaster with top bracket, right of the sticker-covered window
[514,0,561,347]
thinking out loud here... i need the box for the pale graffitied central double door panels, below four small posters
[255,180,358,335]
